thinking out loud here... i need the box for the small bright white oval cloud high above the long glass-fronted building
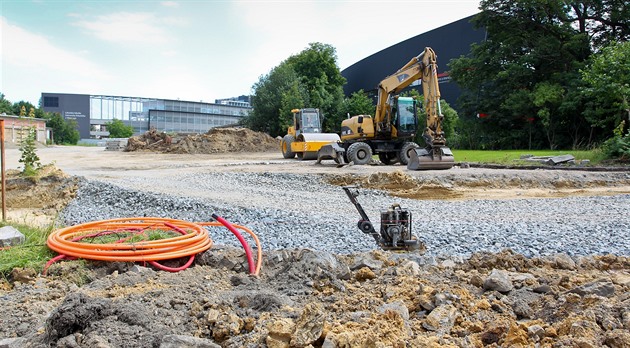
[73,12,174,44]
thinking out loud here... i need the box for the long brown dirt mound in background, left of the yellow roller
[125,128,280,154]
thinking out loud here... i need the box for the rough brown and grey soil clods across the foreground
[0,248,630,347]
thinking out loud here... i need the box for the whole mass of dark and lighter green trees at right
[449,0,630,149]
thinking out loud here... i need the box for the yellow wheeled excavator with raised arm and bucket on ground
[318,47,455,170]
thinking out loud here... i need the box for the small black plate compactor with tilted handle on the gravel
[343,186,425,251]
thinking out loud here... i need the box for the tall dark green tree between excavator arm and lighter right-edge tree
[449,0,591,148]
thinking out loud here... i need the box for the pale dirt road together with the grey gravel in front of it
[8,147,630,257]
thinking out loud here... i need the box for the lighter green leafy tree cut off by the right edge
[582,42,630,137]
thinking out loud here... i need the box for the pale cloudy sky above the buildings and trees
[0,0,479,106]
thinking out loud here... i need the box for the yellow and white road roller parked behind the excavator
[280,108,340,160]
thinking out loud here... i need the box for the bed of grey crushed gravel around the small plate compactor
[59,173,630,257]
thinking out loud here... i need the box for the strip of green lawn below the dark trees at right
[452,150,604,165]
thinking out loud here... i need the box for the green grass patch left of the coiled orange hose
[0,222,57,279]
